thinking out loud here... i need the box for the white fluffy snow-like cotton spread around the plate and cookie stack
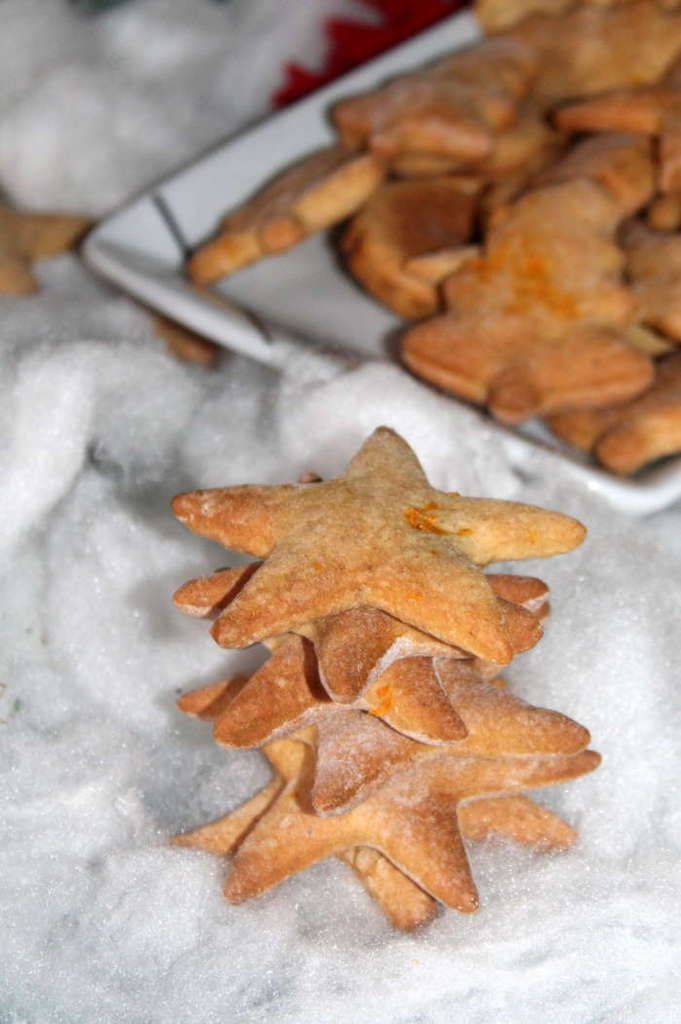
[0,0,681,1024]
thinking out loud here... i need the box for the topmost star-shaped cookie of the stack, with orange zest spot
[173,427,585,664]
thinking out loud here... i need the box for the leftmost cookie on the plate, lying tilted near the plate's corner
[187,145,385,285]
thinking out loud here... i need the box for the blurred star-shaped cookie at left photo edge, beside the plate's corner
[0,204,90,295]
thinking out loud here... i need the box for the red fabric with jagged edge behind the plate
[272,0,465,106]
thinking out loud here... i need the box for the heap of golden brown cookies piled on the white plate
[187,0,681,473]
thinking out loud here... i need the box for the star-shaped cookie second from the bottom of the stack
[224,750,600,912]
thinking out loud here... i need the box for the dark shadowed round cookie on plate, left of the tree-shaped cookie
[341,177,476,319]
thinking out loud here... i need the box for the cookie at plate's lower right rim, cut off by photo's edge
[549,353,681,474]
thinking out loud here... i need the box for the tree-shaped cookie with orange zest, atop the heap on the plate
[402,178,652,423]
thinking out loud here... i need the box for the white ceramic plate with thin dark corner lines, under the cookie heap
[83,13,681,514]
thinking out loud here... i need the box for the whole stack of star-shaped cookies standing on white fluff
[173,427,600,930]
